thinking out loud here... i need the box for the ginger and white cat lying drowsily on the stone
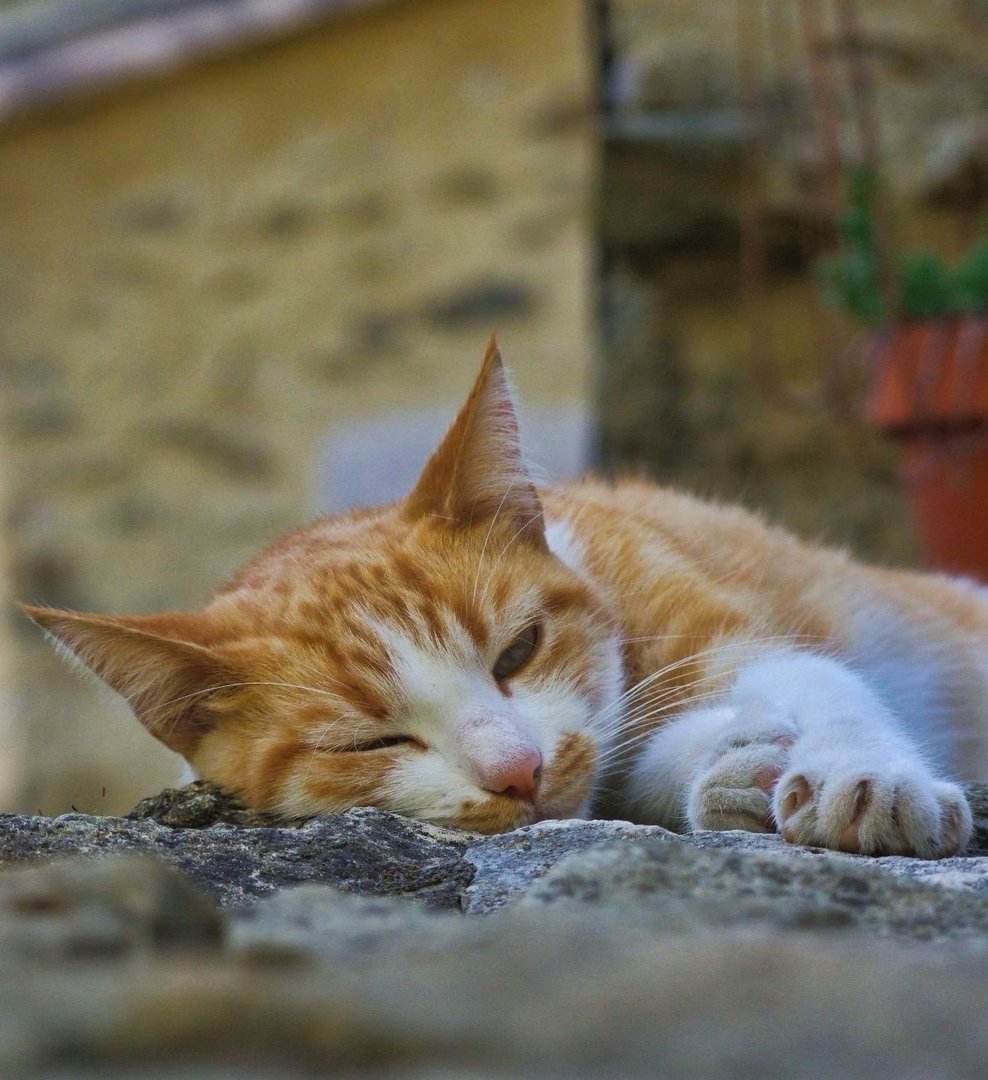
[26,341,988,858]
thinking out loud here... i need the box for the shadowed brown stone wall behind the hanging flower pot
[599,0,988,563]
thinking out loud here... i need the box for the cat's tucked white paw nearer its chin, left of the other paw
[686,734,793,833]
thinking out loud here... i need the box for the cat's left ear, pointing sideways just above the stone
[22,604,235,756]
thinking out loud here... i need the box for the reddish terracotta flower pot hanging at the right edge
[865,316,988,582]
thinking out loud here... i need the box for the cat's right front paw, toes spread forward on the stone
[773,760,972,859]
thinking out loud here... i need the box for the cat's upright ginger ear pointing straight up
[405,335,545,548]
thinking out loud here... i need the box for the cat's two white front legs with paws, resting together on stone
[632,652,971,858]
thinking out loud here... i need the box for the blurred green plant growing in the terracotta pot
[820,168,988,329]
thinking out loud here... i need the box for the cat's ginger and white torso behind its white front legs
[544,482,988,764]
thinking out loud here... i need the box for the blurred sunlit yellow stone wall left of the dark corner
[0,0,593,812]
